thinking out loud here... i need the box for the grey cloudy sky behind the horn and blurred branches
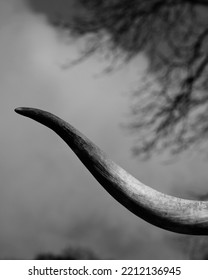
[0,0,208,259]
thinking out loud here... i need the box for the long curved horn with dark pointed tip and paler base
[15,108,208,235]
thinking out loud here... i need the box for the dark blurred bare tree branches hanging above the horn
[52,0,208,157]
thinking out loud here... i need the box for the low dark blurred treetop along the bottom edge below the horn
[35,247,100,260]
